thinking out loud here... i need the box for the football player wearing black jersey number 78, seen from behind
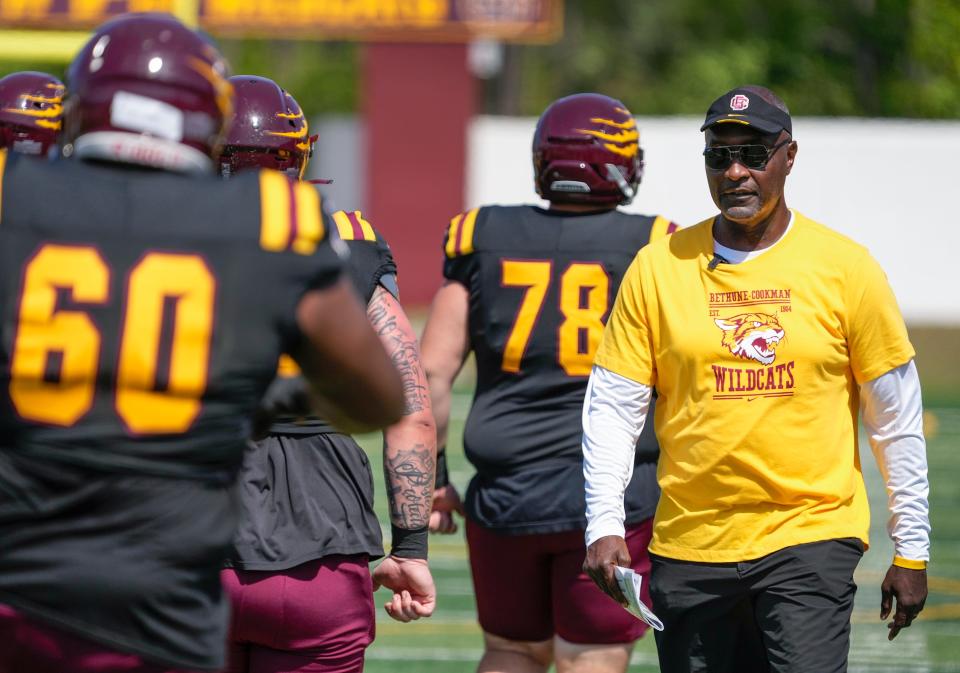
[423,94,676,672]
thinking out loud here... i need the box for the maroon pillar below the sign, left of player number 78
[361,43,476,306]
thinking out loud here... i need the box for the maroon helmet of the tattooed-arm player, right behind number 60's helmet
[220,75,317,180]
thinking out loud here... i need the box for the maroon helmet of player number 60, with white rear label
[63,14,233,172]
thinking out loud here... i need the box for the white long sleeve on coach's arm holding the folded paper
[583,365,651,546]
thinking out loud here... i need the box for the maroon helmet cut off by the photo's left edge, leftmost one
[0,71,63,155]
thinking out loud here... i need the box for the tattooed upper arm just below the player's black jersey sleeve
[367,287,430,416]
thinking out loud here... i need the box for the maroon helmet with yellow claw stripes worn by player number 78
[533,93,643,208]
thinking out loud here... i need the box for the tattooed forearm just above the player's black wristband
[383,444,435,528]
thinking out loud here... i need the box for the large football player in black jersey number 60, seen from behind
[0,14,403,673]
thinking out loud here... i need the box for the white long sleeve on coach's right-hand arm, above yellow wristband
[860,360,930,561]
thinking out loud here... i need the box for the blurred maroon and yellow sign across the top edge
[0,0,563,42]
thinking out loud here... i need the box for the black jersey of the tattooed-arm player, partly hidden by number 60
[227,211,399,571]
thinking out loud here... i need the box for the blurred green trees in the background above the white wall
[0,0,960,118]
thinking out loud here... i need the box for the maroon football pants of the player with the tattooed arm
[221,554,375,673]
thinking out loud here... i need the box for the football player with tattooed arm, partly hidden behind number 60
[220,75,437,673]
